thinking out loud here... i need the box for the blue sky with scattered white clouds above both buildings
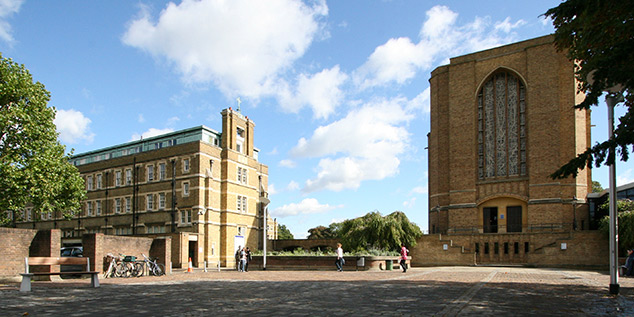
[0,0,634,238]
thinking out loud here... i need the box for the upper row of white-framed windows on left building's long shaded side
[86,158,191,190]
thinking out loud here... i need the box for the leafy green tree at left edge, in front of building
[0,55,85,225]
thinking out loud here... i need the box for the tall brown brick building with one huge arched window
[412,35,602,264]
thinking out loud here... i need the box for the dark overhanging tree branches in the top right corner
[545,0,634,178]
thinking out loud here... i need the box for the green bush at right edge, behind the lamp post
[599,199,634,254]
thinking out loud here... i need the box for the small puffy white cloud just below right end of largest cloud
[278,65,348,119]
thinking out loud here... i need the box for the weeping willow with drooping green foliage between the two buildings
[337,211,423,251]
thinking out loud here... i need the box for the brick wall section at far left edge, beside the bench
[0,228,37,281]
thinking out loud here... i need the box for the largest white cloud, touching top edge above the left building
[122,0,328,98]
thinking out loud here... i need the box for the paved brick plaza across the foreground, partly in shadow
[0,267,634,316]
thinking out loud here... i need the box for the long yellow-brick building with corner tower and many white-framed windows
[16,108,277,266]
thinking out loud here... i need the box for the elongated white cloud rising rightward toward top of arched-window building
[352,5,525,90]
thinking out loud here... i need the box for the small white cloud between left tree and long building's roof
[53,109,95,144]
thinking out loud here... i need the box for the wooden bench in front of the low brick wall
[20,257,99,292]
